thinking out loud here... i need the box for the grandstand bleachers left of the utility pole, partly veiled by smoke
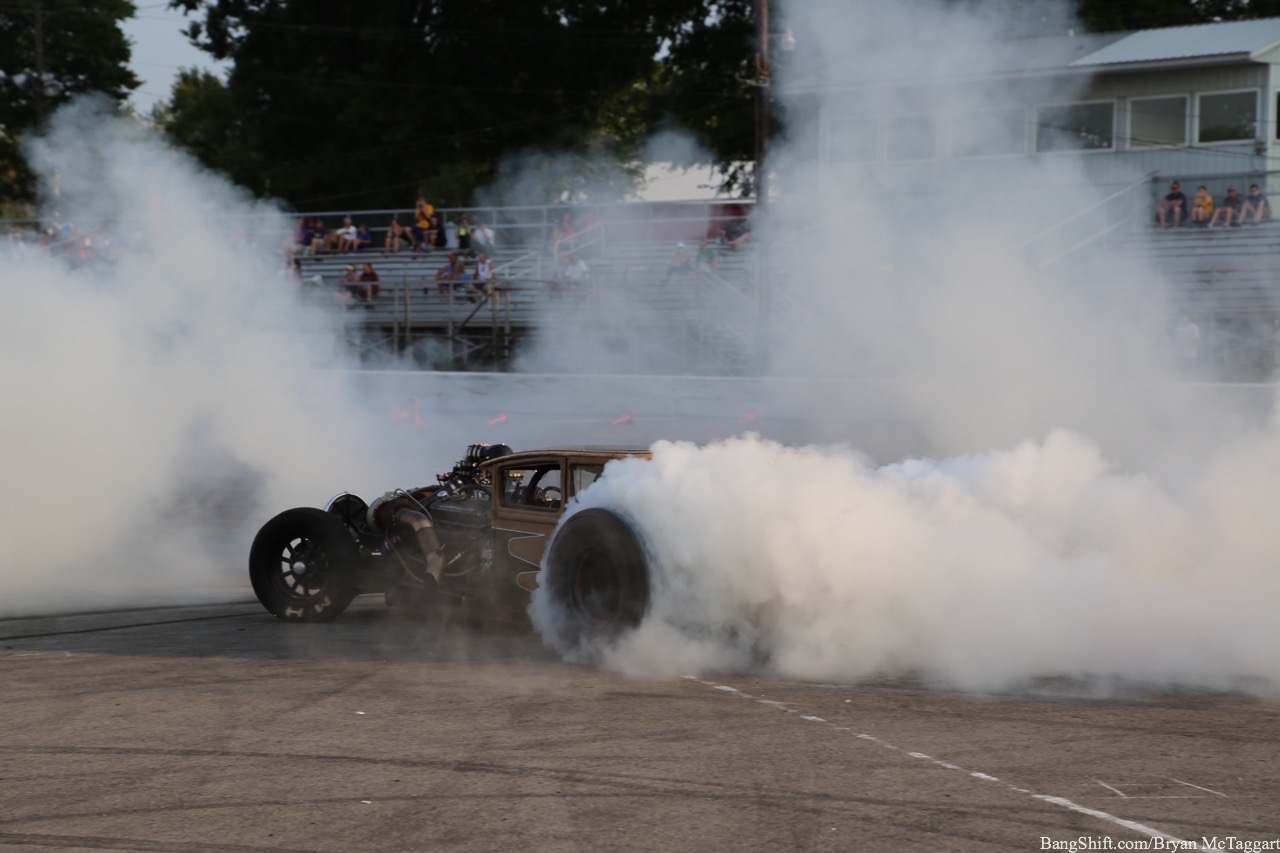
[298,233,754,373]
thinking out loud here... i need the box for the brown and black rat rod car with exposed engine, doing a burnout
[248,444,649,639]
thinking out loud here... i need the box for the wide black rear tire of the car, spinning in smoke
[545,508,649,647]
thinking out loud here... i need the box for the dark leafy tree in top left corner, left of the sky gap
[0,0,138,200]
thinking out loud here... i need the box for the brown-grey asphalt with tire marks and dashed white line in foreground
[0,603,1280,850]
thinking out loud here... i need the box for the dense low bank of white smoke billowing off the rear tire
[535,432,1280,692]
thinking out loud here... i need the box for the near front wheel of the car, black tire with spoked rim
[248,507,360,622]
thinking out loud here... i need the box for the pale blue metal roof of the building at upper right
[1070,18,1280,68]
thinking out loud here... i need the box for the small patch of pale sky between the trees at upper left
[124,0,224,115]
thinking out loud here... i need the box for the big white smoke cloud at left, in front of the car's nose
[0,101,409,613]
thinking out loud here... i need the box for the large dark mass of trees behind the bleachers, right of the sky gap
[169,0,732,210]
